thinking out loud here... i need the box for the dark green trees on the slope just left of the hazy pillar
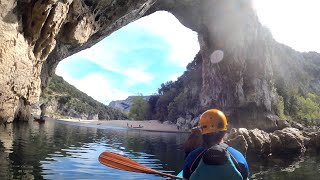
[148,53,202,122]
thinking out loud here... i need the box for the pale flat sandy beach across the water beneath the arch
[57,119,187,132]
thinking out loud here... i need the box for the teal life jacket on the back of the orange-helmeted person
[190,143,243,180]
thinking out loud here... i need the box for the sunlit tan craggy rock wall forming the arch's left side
[0,0,158,122]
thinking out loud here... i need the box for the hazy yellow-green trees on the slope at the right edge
[274,52,320,122]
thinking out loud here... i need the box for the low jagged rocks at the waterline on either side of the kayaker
[176,116,320,157]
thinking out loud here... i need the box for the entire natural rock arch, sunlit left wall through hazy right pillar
[0,0,319,126]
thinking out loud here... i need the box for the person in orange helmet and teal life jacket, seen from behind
[183,109,249,180]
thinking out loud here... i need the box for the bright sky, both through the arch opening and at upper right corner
[56,0,320,105]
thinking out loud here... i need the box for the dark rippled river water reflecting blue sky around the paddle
[0,120,320,180]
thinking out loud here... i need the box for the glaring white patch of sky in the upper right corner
[253,0,320,52]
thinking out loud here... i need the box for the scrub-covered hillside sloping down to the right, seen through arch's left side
[34,75,127,120]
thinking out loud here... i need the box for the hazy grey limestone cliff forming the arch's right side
[150,0,320,131]
